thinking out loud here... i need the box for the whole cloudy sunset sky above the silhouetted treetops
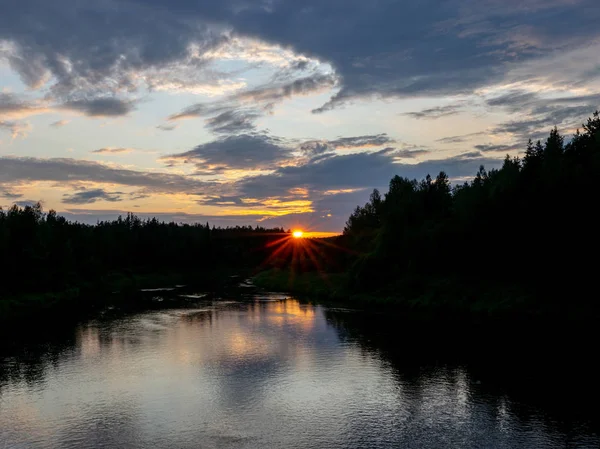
[0,0,600,232]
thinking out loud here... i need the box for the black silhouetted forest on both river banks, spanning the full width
[0,112,600,322]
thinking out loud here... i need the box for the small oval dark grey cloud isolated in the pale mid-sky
[162,134,291,170]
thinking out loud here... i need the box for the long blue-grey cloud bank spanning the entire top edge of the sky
[0,0,600,111]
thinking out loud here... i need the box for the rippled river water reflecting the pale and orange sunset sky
[0,296,600,449]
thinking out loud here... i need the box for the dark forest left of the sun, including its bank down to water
[0,208,287,322]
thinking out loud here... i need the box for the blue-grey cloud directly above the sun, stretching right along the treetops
[227,148,502,231]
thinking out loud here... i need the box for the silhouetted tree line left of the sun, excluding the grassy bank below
[0,204,289,298]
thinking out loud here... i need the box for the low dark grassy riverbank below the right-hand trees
[253,269,597,322]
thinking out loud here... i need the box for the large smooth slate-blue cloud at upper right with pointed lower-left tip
[224,0,598,111]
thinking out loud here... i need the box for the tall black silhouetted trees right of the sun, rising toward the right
[341,112,600,307]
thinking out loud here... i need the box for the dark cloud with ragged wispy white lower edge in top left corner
[0,0,224,98]
